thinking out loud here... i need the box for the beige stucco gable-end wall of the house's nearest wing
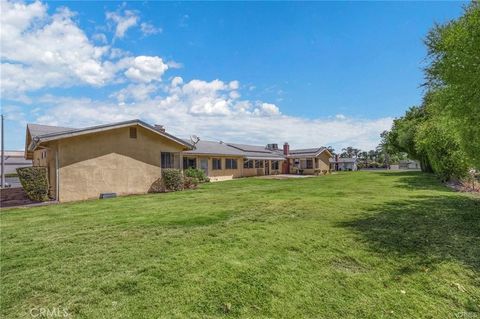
[53,126,185,202]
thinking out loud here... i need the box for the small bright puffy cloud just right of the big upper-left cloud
[125,56,168,83]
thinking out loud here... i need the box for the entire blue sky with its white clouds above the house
[1,1,464,149]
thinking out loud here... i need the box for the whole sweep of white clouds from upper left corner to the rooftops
[0,2,392,149]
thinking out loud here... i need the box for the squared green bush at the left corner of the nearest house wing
[17,166,49,202]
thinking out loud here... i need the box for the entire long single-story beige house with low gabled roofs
[25,120,332,202]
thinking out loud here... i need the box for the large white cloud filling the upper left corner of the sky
[0,2,112,96]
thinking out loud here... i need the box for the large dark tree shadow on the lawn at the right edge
[341,195,480,271]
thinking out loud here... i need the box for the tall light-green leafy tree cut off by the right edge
[425,2,480,167]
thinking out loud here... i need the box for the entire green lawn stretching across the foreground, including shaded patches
[0,172,480,318]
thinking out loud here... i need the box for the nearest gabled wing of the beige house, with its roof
[25,120,192,202]
